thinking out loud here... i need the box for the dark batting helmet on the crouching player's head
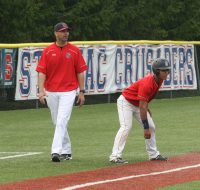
[152,58,171,75]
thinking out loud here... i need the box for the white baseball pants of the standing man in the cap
[46,90,76,154]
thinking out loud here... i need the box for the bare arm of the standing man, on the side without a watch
[38,72,46,104]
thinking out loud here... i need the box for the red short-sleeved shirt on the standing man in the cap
[36,43,88,92]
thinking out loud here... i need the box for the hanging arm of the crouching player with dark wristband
[139,100,151,139]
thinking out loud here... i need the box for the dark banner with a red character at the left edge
[0,49,17,88]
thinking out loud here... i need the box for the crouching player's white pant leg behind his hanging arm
[134,112,160,159]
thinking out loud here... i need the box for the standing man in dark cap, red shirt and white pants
[36,22,87,162]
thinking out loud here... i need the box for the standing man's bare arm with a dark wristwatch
[76,72,85,106]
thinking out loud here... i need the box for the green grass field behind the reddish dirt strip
[0,97,200,189]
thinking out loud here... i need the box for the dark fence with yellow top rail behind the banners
[0,41,200,110]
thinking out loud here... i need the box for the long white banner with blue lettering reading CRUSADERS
[15,44,197,100]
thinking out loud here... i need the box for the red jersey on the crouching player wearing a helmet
[122,74,163,107]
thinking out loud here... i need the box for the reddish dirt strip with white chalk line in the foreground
[0,153,200,190]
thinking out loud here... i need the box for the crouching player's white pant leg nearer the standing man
[110,95,133,160]
